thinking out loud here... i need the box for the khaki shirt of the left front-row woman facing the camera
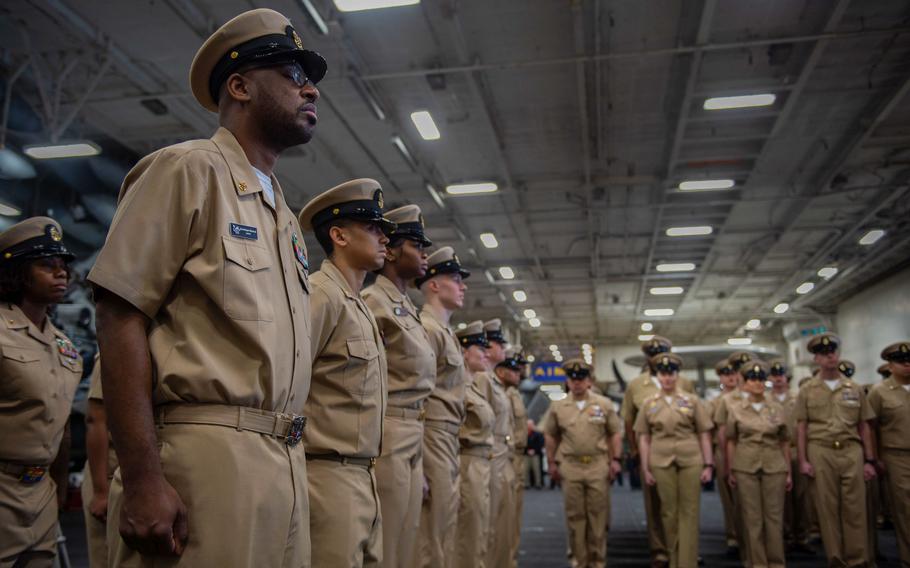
[635,391,714,467]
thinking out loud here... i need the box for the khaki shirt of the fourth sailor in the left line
[420,306,467,425]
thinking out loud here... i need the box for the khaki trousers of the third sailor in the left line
[376,414,423,568]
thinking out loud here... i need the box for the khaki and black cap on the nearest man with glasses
[190,8,327,112]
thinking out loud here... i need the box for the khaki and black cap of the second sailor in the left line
[299,178,395,234]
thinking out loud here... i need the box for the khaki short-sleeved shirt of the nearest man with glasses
[88,128,312,414]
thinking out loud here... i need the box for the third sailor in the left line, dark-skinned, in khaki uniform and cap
[362,205,436,568]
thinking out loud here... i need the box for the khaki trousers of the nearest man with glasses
[107,424,310,568]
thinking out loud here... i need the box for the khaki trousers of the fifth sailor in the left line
[455,450,492,568]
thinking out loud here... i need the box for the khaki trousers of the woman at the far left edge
[0,474,58,568]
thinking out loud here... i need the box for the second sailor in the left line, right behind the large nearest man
[299,179,395,568]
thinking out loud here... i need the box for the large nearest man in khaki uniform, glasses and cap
[88,9,326,567]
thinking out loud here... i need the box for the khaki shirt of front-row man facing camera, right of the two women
[796,375,875,446]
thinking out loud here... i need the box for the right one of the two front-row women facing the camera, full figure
[718,359,792,568]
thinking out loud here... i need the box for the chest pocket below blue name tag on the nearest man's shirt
[222,237,274,321]
